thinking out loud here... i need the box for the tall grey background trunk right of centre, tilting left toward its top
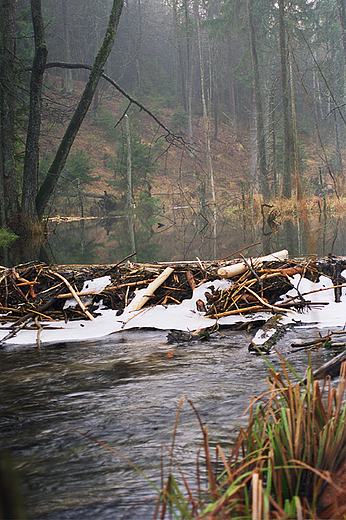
[247,0,270,201]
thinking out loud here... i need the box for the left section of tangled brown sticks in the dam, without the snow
[0,264,210,323]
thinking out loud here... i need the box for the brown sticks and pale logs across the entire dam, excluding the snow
[0,251,346,336]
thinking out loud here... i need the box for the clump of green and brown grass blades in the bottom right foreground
[155,362,346,520]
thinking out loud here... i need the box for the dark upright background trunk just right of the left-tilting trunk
[278,0,293,199]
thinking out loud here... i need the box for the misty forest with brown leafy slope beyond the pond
[0,0,346,254]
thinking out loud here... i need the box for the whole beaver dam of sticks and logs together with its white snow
[0,250,346,358]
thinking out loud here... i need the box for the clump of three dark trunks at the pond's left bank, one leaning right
[0,0,123,233]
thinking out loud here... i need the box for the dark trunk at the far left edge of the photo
[0,0,19,226]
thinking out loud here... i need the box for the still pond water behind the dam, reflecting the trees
[0,210,346,266]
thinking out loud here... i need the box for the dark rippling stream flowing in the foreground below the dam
[0,328,330,520]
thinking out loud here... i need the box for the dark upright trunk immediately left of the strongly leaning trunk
[22,0,48,223]
